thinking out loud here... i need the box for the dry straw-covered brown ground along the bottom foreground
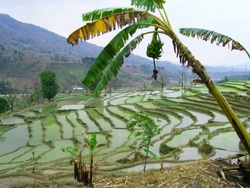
[1,160,250,188]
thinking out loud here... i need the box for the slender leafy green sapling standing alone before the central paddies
[127,111,162,171]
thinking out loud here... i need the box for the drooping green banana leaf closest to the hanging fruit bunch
[89,35,143,97]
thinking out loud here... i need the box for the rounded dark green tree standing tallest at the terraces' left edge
[40,70,59,101]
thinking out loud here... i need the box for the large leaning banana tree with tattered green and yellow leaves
[67,0,250,154]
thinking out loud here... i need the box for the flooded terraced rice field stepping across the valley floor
[0,81,250,176]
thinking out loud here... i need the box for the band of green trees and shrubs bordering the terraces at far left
[0,70,59,113]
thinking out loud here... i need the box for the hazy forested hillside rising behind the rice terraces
[0,14,247,90]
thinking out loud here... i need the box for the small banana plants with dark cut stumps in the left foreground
[61,131,97,187]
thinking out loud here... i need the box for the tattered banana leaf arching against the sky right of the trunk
[180,28,250,58]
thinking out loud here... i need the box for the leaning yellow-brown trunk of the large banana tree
[176,39,250,155]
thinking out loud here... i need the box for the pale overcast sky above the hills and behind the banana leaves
[0,0,250,67]
